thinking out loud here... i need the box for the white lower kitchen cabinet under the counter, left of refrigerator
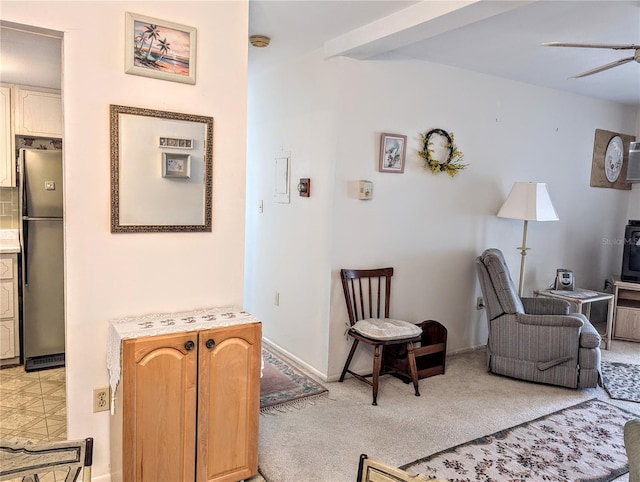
[0,254,20,362]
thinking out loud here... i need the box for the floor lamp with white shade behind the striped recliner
[498,182,558,297]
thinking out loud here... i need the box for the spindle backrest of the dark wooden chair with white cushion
[340,268,393,326]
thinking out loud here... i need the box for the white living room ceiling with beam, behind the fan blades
[249,0,640,106]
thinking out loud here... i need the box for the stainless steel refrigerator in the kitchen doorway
[19,149,65,371]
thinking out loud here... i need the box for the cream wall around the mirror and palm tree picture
[2,1,248,480]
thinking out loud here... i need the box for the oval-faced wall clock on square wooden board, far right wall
[589,129,635,190]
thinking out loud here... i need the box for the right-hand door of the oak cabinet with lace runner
[196,323,261,482]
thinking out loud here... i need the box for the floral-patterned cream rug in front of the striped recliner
[400,399,635,482]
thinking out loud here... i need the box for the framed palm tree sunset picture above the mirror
[125,12,196,84]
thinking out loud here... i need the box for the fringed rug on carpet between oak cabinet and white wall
[260,345,329,414]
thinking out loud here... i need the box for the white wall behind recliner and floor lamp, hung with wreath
[245,52,637,379]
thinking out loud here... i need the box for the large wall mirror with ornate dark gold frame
[110,105,213,233]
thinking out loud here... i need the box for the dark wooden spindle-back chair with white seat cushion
[340,268,422,405]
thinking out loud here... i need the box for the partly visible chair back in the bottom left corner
[0,438,93,482]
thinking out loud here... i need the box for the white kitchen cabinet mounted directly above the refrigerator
[13,86,63,138]
